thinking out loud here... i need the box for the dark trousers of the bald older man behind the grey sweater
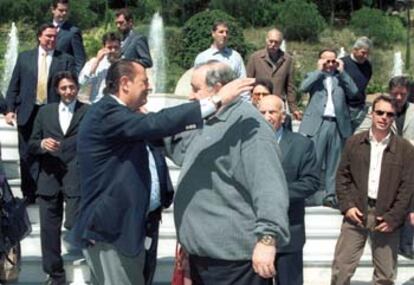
[275,250,303,285]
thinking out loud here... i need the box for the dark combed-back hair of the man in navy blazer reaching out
[104,59,142,94]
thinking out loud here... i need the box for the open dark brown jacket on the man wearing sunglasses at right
[336,131,414,229]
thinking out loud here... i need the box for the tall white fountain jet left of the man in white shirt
[149,12,166,93]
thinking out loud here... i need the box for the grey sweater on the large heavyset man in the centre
[166,100,289,260]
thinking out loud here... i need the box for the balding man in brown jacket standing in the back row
[247,29,302,120]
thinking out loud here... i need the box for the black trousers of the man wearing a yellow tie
[17,106,40,202]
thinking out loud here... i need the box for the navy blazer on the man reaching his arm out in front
[68,96,202,256]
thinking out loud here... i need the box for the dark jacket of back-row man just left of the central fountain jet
[121,30,152,68]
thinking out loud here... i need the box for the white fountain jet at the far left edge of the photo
[1,22,19,95]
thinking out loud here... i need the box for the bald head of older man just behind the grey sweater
[258,95,285,130]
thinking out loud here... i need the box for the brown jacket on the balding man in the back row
[246,49,298,112]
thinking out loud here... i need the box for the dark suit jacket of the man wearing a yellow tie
[6,48,75,126]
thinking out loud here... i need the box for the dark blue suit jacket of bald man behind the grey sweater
[278,129,320,252]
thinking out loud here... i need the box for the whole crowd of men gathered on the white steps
[2,0,414,285]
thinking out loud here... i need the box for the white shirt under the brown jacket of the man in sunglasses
[368,129,391,199]
